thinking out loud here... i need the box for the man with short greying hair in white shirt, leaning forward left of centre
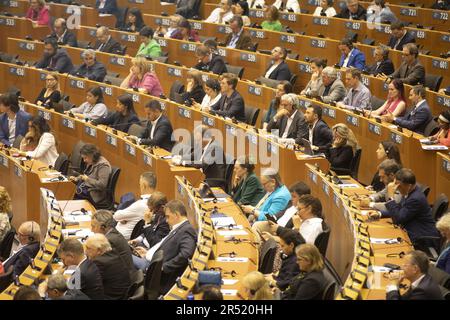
[114,171,156,240]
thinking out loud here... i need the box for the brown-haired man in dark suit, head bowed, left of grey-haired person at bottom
[58,238,104,300]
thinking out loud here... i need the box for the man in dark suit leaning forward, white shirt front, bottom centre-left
[136,200,197,294]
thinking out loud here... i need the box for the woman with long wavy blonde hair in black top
[328,123,358,174]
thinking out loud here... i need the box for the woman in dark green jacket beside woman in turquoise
[231,156,264,206]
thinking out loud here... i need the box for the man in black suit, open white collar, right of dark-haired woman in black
[127,100,174,151]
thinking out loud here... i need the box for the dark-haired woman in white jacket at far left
[20,116,59,166]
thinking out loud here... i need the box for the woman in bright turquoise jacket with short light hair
[241,168,291,221]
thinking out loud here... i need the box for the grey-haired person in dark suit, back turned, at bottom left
[85,233,131,300]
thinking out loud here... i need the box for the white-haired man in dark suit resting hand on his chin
[267,93,308,144]
